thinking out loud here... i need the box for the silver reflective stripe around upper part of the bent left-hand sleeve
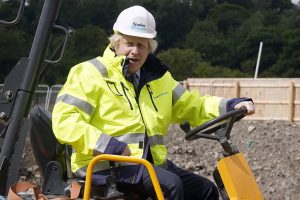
[55,94,94,115]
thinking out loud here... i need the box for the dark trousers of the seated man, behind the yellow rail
[118,161,219,200]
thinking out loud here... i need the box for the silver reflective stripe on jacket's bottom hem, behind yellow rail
[75,161,137,178]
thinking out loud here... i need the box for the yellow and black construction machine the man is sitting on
[0,0,263,200]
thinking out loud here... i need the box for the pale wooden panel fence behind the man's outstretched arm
[183,78,300,122]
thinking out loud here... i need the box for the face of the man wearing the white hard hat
[116,35,149,73]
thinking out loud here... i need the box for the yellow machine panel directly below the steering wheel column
[218,153,264,200]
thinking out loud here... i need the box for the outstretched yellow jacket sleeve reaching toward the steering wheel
[172,77,228,126]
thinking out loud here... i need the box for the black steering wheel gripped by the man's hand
[180,108,247,141]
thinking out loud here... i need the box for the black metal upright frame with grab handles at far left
[0,0,70,195]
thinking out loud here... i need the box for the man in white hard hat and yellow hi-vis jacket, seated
[53,6,254,200]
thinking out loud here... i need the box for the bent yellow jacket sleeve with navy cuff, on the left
[52,64,126,156]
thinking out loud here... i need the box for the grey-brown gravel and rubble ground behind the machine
[19,120,300,200]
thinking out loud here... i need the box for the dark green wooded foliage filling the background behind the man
[0,0,300,84]
